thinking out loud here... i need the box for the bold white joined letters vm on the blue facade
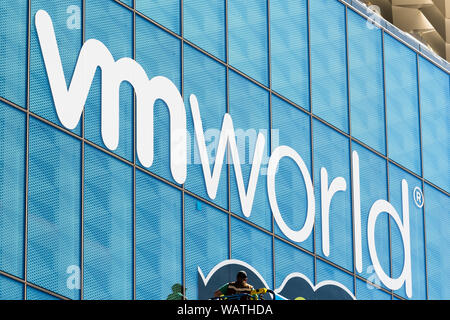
[36,10,187,183]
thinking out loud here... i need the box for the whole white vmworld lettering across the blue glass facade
[35,10,412,297]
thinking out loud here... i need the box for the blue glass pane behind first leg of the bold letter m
[85,0,133,161]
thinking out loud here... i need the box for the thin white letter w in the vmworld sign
[189,94,266,218]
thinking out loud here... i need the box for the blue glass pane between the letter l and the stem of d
[352,143,390,285]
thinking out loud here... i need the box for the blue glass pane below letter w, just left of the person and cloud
[184,196,229,300]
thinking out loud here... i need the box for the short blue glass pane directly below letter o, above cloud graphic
[275,239,314,288]
